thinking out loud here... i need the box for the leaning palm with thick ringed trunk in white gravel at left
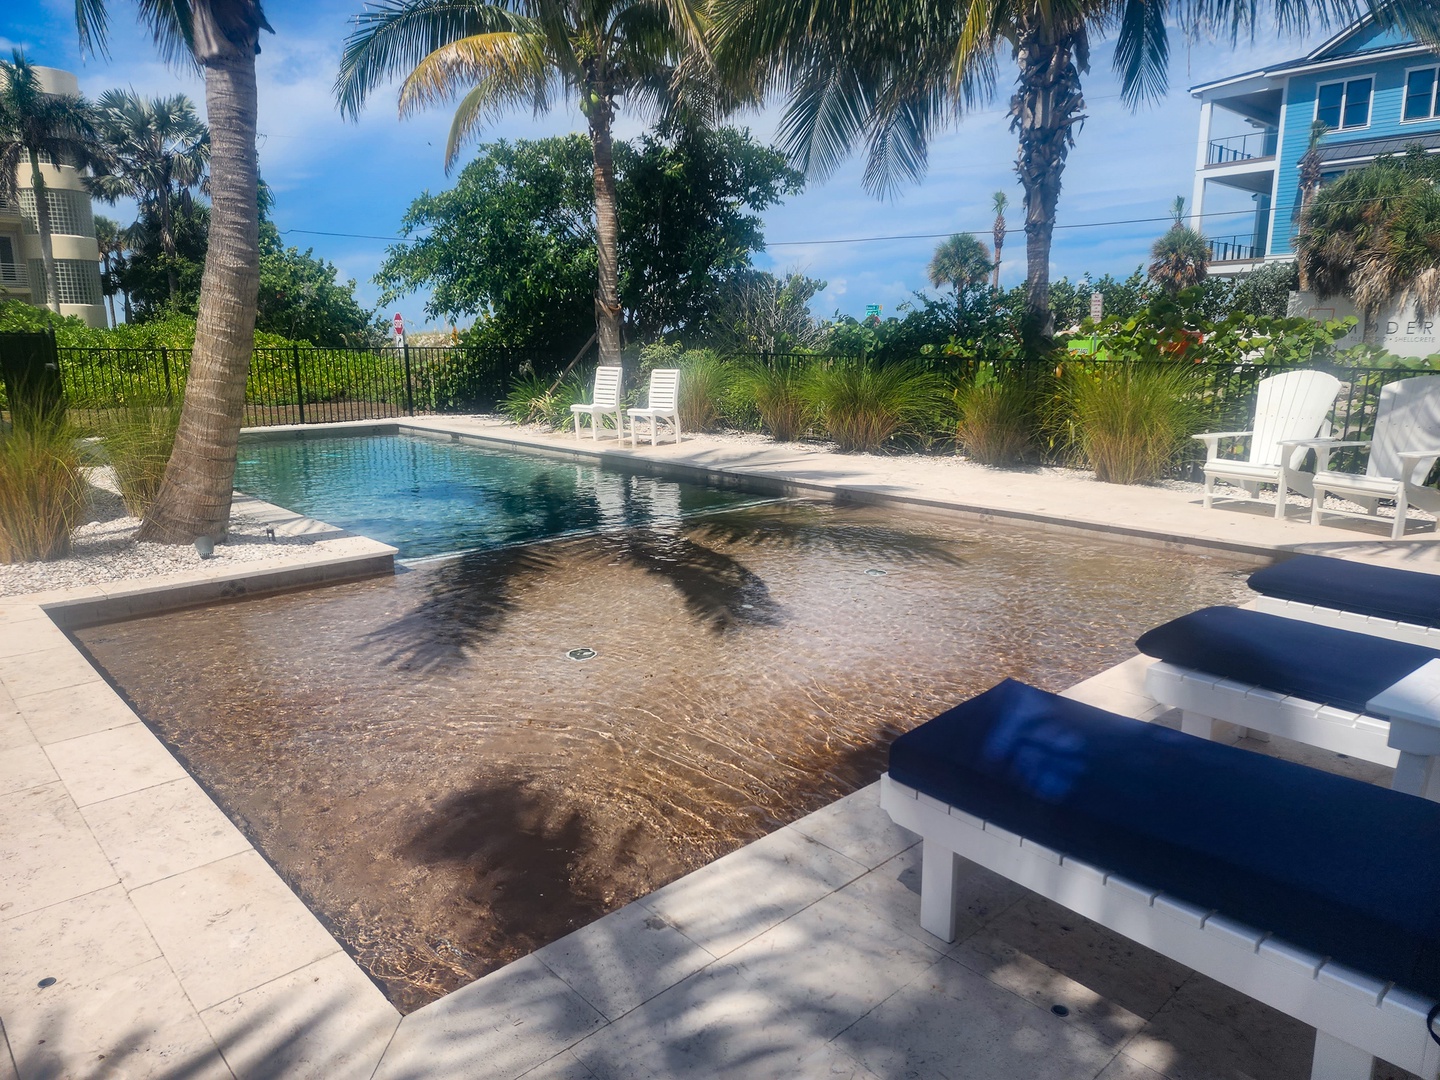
[75,0,271,544]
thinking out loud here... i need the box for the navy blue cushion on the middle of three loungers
[1135,608,1440,713]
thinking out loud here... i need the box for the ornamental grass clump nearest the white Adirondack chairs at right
[1063,363,1195,484]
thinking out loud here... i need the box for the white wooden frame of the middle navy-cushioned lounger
[1145,660,1440,802]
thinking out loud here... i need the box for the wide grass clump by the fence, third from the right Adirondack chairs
[808,360,948,452]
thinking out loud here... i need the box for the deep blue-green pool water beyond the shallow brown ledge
[235,435,755,559]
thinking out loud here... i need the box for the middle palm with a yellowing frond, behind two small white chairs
[336,0,720,364]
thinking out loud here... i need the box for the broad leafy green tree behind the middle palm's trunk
[376,128,801,357]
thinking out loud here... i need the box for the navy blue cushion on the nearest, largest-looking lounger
[890,680,1440,996]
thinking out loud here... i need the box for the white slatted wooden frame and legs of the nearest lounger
[880,775,1440,1080]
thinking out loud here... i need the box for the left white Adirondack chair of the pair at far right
[1194,372,1341,517]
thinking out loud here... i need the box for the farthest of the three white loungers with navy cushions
[1250,554,1440,649]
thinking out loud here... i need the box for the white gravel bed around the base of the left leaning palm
[0,468,315,596]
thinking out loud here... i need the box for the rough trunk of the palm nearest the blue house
[1009,23,1089,347]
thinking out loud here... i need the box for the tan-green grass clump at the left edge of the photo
[0,416,86,563]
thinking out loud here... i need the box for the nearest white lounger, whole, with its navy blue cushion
[880,681,1440,1080]
